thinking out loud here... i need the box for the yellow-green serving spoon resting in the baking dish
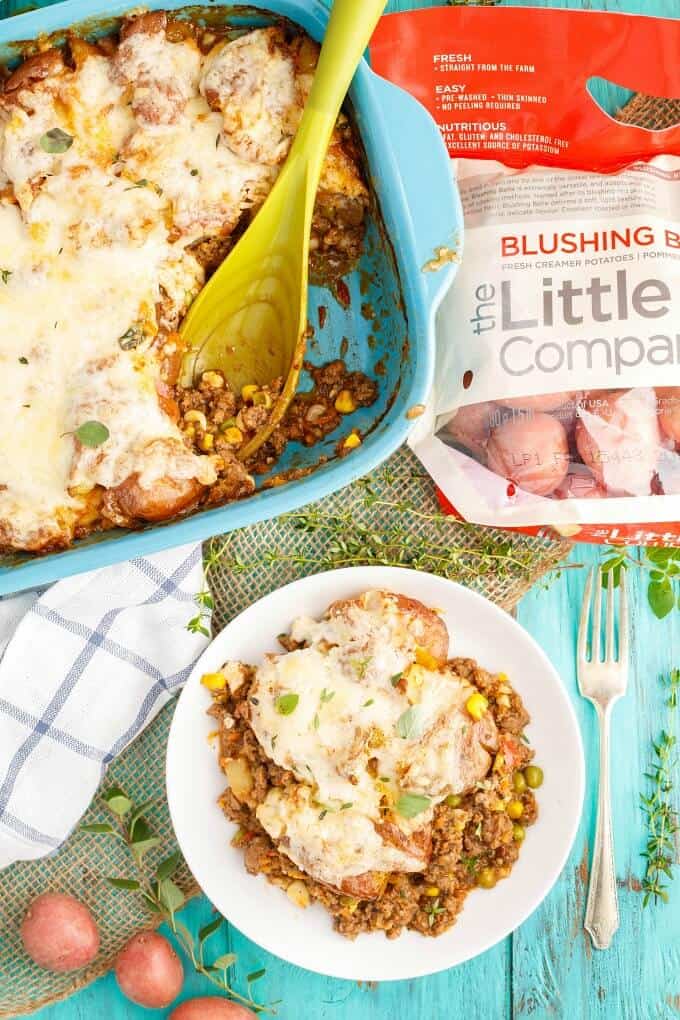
[181,0,386,460]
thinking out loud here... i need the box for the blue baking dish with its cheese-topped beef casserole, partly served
[0,0,460,591]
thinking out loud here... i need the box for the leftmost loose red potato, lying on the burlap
[21,893,99,973]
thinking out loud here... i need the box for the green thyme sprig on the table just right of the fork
[640,669,680,907]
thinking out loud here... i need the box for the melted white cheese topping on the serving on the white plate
[241,593,498,887]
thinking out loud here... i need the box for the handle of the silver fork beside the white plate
[583,704,619,950]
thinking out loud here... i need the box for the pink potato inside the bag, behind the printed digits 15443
[576,388,662,496]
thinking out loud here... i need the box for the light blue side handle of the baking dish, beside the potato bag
[373,72,463,310]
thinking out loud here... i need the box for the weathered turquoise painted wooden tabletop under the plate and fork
[0,0,680,1020]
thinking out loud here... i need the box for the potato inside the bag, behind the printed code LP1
[486,412,569,496]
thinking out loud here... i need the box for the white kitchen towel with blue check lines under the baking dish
[0,546,208,868]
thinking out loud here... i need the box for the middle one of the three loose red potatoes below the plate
[115,931,185,1010]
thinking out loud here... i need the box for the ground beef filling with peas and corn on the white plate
[210,659,538,938]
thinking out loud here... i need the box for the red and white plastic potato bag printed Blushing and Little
[371,8,680,545]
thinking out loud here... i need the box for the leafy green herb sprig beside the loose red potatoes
[81,786,276,1015]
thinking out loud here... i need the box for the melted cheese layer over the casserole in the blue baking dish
[0,21,348,549]
